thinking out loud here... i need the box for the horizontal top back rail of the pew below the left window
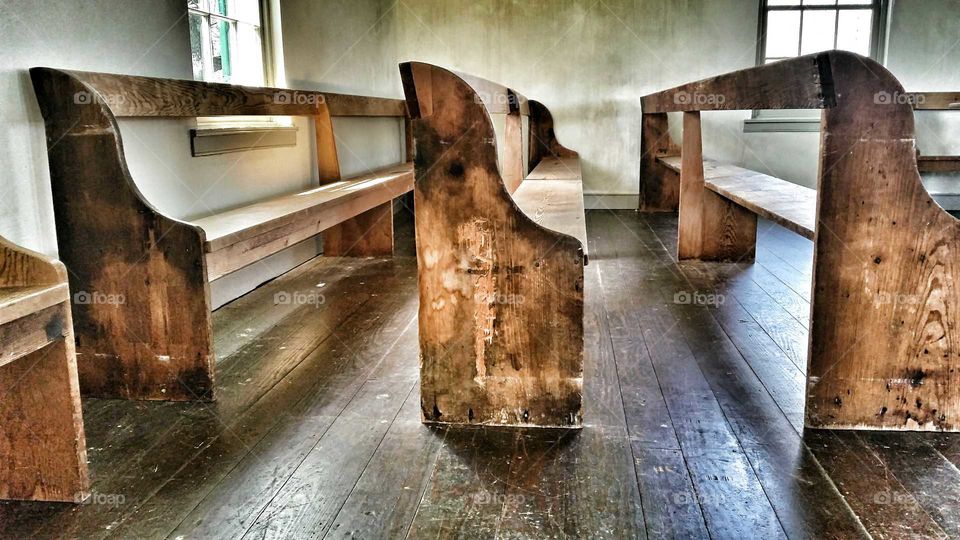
[53,68,407,118]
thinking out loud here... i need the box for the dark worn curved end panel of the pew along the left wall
[30,68,214,401]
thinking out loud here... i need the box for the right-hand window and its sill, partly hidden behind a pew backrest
[744,0,887,132]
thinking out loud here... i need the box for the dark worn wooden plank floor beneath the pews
[0,211,960,539]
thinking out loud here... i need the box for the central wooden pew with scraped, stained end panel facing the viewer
[400,63,587,427]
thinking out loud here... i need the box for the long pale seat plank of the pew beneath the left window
[197,163,413,281]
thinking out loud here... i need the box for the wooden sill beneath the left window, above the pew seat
[190,125,297,157]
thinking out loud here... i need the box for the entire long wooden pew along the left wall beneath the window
[30,68,413,401]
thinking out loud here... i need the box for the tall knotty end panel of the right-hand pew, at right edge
[807,53,960,431]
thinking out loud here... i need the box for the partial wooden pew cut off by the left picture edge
[0,237,90,502]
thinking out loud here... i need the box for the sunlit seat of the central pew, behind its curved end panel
[513,158,589,264]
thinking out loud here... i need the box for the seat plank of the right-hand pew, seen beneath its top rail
[658,156,817,240]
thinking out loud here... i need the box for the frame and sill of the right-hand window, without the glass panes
[743,0,890,133]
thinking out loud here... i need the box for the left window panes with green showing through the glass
[187,0,267,86]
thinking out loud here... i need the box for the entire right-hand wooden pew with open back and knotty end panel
[643,51,960,431]
